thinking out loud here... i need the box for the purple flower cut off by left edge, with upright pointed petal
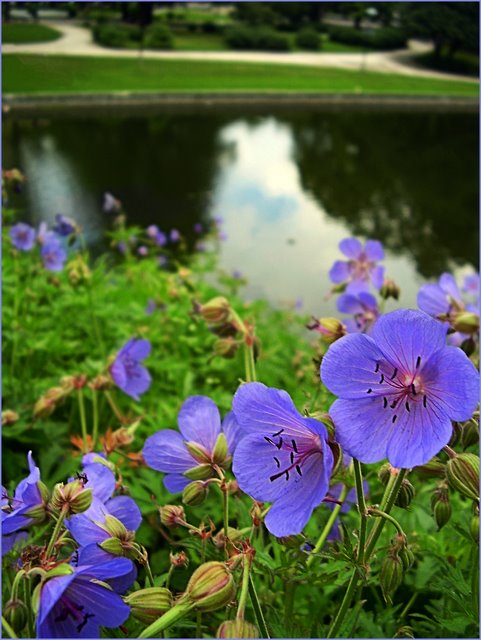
[2,451,44,554]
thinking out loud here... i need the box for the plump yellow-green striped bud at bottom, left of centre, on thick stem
[181,561,235,611]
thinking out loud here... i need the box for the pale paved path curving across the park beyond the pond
[2,22,478,82]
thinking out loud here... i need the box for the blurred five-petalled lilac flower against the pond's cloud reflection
[329,238,384,293]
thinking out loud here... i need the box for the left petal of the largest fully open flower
[321,336,385,398]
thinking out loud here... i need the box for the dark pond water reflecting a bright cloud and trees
[3,108,479,314]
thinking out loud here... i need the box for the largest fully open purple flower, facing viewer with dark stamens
[321,309,479,468]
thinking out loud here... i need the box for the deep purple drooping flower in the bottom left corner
[37,549,133,638]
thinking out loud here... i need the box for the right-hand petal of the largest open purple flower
[421,347,479,421]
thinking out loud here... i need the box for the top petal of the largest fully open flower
[372,309,446,376]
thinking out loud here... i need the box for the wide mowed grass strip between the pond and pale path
[3,54,479,96]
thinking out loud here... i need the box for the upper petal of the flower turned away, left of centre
[177,396,220,452]
